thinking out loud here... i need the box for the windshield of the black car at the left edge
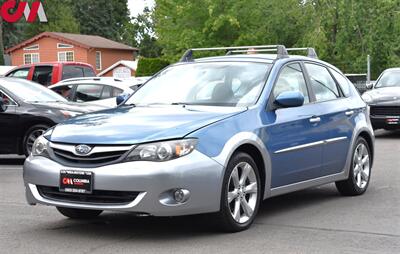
[3,80,67,102]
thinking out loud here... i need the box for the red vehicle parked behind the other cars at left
[5,62,96,86]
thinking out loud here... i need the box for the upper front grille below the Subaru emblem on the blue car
[53,148,126,165]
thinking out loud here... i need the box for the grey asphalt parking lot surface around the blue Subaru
[0,131,400,253]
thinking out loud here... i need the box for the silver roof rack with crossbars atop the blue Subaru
[180,45,318,62]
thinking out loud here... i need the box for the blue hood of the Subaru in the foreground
[50,106,246,145]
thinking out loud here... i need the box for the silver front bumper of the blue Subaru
[24,151,224,216]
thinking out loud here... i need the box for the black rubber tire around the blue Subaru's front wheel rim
[220,152,263,232]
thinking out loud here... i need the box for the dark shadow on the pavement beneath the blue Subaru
[39,187,340,238]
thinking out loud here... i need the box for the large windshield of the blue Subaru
[126,62,271,107]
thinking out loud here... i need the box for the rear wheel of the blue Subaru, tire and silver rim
[335,137,372,196]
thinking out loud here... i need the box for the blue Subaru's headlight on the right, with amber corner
[125,139,197,162]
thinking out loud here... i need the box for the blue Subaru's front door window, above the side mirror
[273,63,310,104]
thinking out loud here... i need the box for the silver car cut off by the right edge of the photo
[362,68,400,130]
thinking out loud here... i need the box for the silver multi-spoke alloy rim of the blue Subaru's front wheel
[227,162,258,224]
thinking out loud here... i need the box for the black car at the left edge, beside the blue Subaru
[0,78,104,155]
